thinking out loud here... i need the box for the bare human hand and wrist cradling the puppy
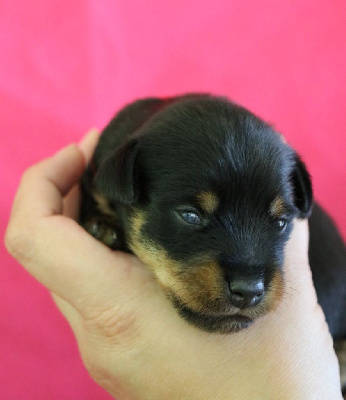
[5,132,342,400]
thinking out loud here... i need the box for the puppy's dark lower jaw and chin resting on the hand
[173,298,254,334]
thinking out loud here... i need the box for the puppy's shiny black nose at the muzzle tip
[229,279,264,308]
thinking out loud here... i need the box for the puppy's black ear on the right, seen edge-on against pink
[291,154,312,218]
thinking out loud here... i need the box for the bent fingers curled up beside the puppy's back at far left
[5,126,98,256]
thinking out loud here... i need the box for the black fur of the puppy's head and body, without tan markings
[80,94,346,339]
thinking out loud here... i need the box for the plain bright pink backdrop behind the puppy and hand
[0,0,346,400]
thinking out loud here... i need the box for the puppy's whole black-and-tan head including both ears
[96,96,312,333]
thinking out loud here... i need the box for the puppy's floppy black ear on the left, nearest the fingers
[95,139,139,204]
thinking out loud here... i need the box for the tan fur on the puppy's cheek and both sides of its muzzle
[129,211,283,317]
